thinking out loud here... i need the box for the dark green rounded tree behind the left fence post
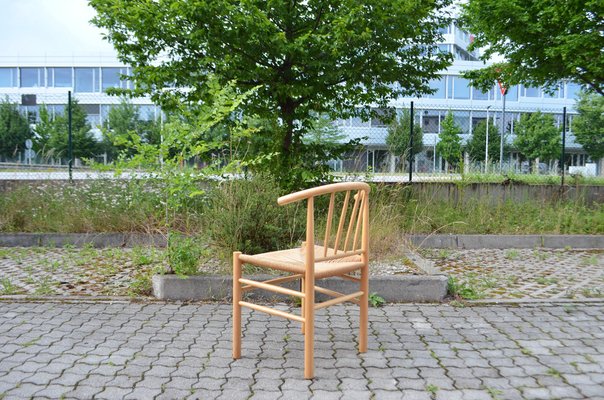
[41,100,100,158]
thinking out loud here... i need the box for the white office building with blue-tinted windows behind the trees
[0,23,591,171]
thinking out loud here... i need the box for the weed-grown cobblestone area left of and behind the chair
[0,247,423,296]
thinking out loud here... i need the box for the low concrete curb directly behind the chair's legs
[152,275,447,303]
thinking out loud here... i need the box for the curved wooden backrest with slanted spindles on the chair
[277,182,370,262]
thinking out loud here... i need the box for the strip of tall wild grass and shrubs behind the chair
[0,180,604,239]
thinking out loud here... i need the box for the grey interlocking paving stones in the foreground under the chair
[0,302,604,400]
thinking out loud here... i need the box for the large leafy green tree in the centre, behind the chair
[90,0,451,177]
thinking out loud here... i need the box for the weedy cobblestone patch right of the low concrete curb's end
[422,249,604,299]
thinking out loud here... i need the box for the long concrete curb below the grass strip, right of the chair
[407,235,604,249]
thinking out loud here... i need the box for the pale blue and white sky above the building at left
[0,0,115,57]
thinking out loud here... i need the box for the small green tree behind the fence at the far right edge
[572,93,604,161]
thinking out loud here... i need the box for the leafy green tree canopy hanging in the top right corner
[461,0,604,95]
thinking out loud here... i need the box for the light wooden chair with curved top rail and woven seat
[233,182,370,379]
